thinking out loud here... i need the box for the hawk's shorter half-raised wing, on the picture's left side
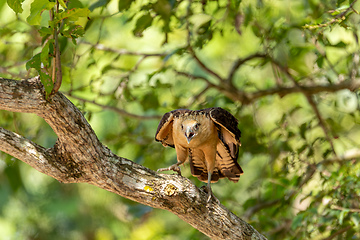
[155,109,191,148]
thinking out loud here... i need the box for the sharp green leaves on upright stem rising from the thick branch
[22,0,90,96]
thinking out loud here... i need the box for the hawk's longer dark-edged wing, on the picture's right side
[209,108,243,182]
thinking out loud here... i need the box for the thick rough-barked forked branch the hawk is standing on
[0,78,266,240]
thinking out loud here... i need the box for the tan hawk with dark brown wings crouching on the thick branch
[155,107,243,202]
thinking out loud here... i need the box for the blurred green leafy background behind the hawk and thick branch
[0,0,360,240]
